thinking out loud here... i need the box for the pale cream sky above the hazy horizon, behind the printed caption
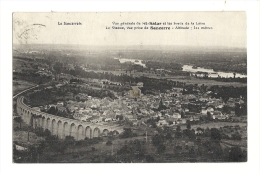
[13,12,247,48]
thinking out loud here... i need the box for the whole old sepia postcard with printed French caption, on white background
[12,11,248,163]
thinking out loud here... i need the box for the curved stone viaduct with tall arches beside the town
[17,97,123,140]
